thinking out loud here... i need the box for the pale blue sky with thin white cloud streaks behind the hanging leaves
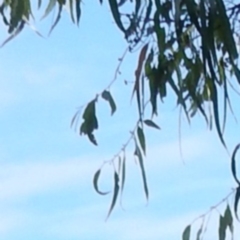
[0,1,240,240]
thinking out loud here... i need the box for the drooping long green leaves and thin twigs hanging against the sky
[0,0,240,240]
